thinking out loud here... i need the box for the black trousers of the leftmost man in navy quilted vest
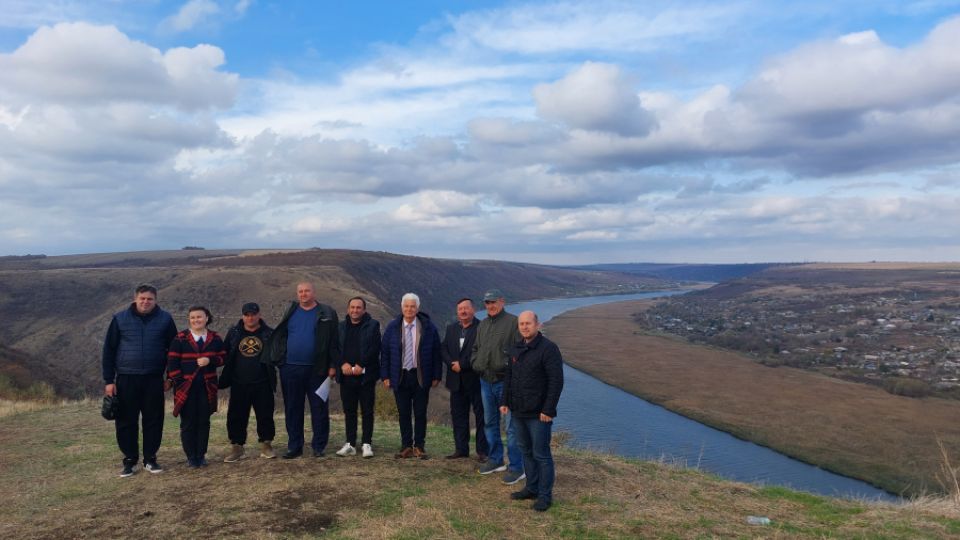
[115,373,164,465]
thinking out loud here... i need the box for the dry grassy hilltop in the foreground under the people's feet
[0,401,960,540]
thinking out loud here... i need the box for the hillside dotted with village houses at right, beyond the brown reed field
[638,263,960,398]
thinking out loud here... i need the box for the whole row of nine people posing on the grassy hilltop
[102,282,563,511]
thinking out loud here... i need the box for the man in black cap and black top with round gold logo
[219,302,277,463]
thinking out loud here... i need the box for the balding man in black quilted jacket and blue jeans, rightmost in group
[500,311,563,512]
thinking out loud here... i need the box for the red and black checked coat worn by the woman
[167,330,227,416]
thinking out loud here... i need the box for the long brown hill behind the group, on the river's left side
[0,249,676,397]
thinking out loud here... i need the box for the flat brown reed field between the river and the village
[548,301,960,495]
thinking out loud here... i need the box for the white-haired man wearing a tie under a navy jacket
[380,293,443,459]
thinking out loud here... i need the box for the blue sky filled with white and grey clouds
[0,0,960,264]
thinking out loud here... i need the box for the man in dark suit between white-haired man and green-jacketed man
[441,298,488,463]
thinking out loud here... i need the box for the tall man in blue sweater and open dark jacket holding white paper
[264,282,341,459]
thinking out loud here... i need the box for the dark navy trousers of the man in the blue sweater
[280,364,330,452]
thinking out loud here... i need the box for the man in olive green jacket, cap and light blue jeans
[470,289,525,484]
